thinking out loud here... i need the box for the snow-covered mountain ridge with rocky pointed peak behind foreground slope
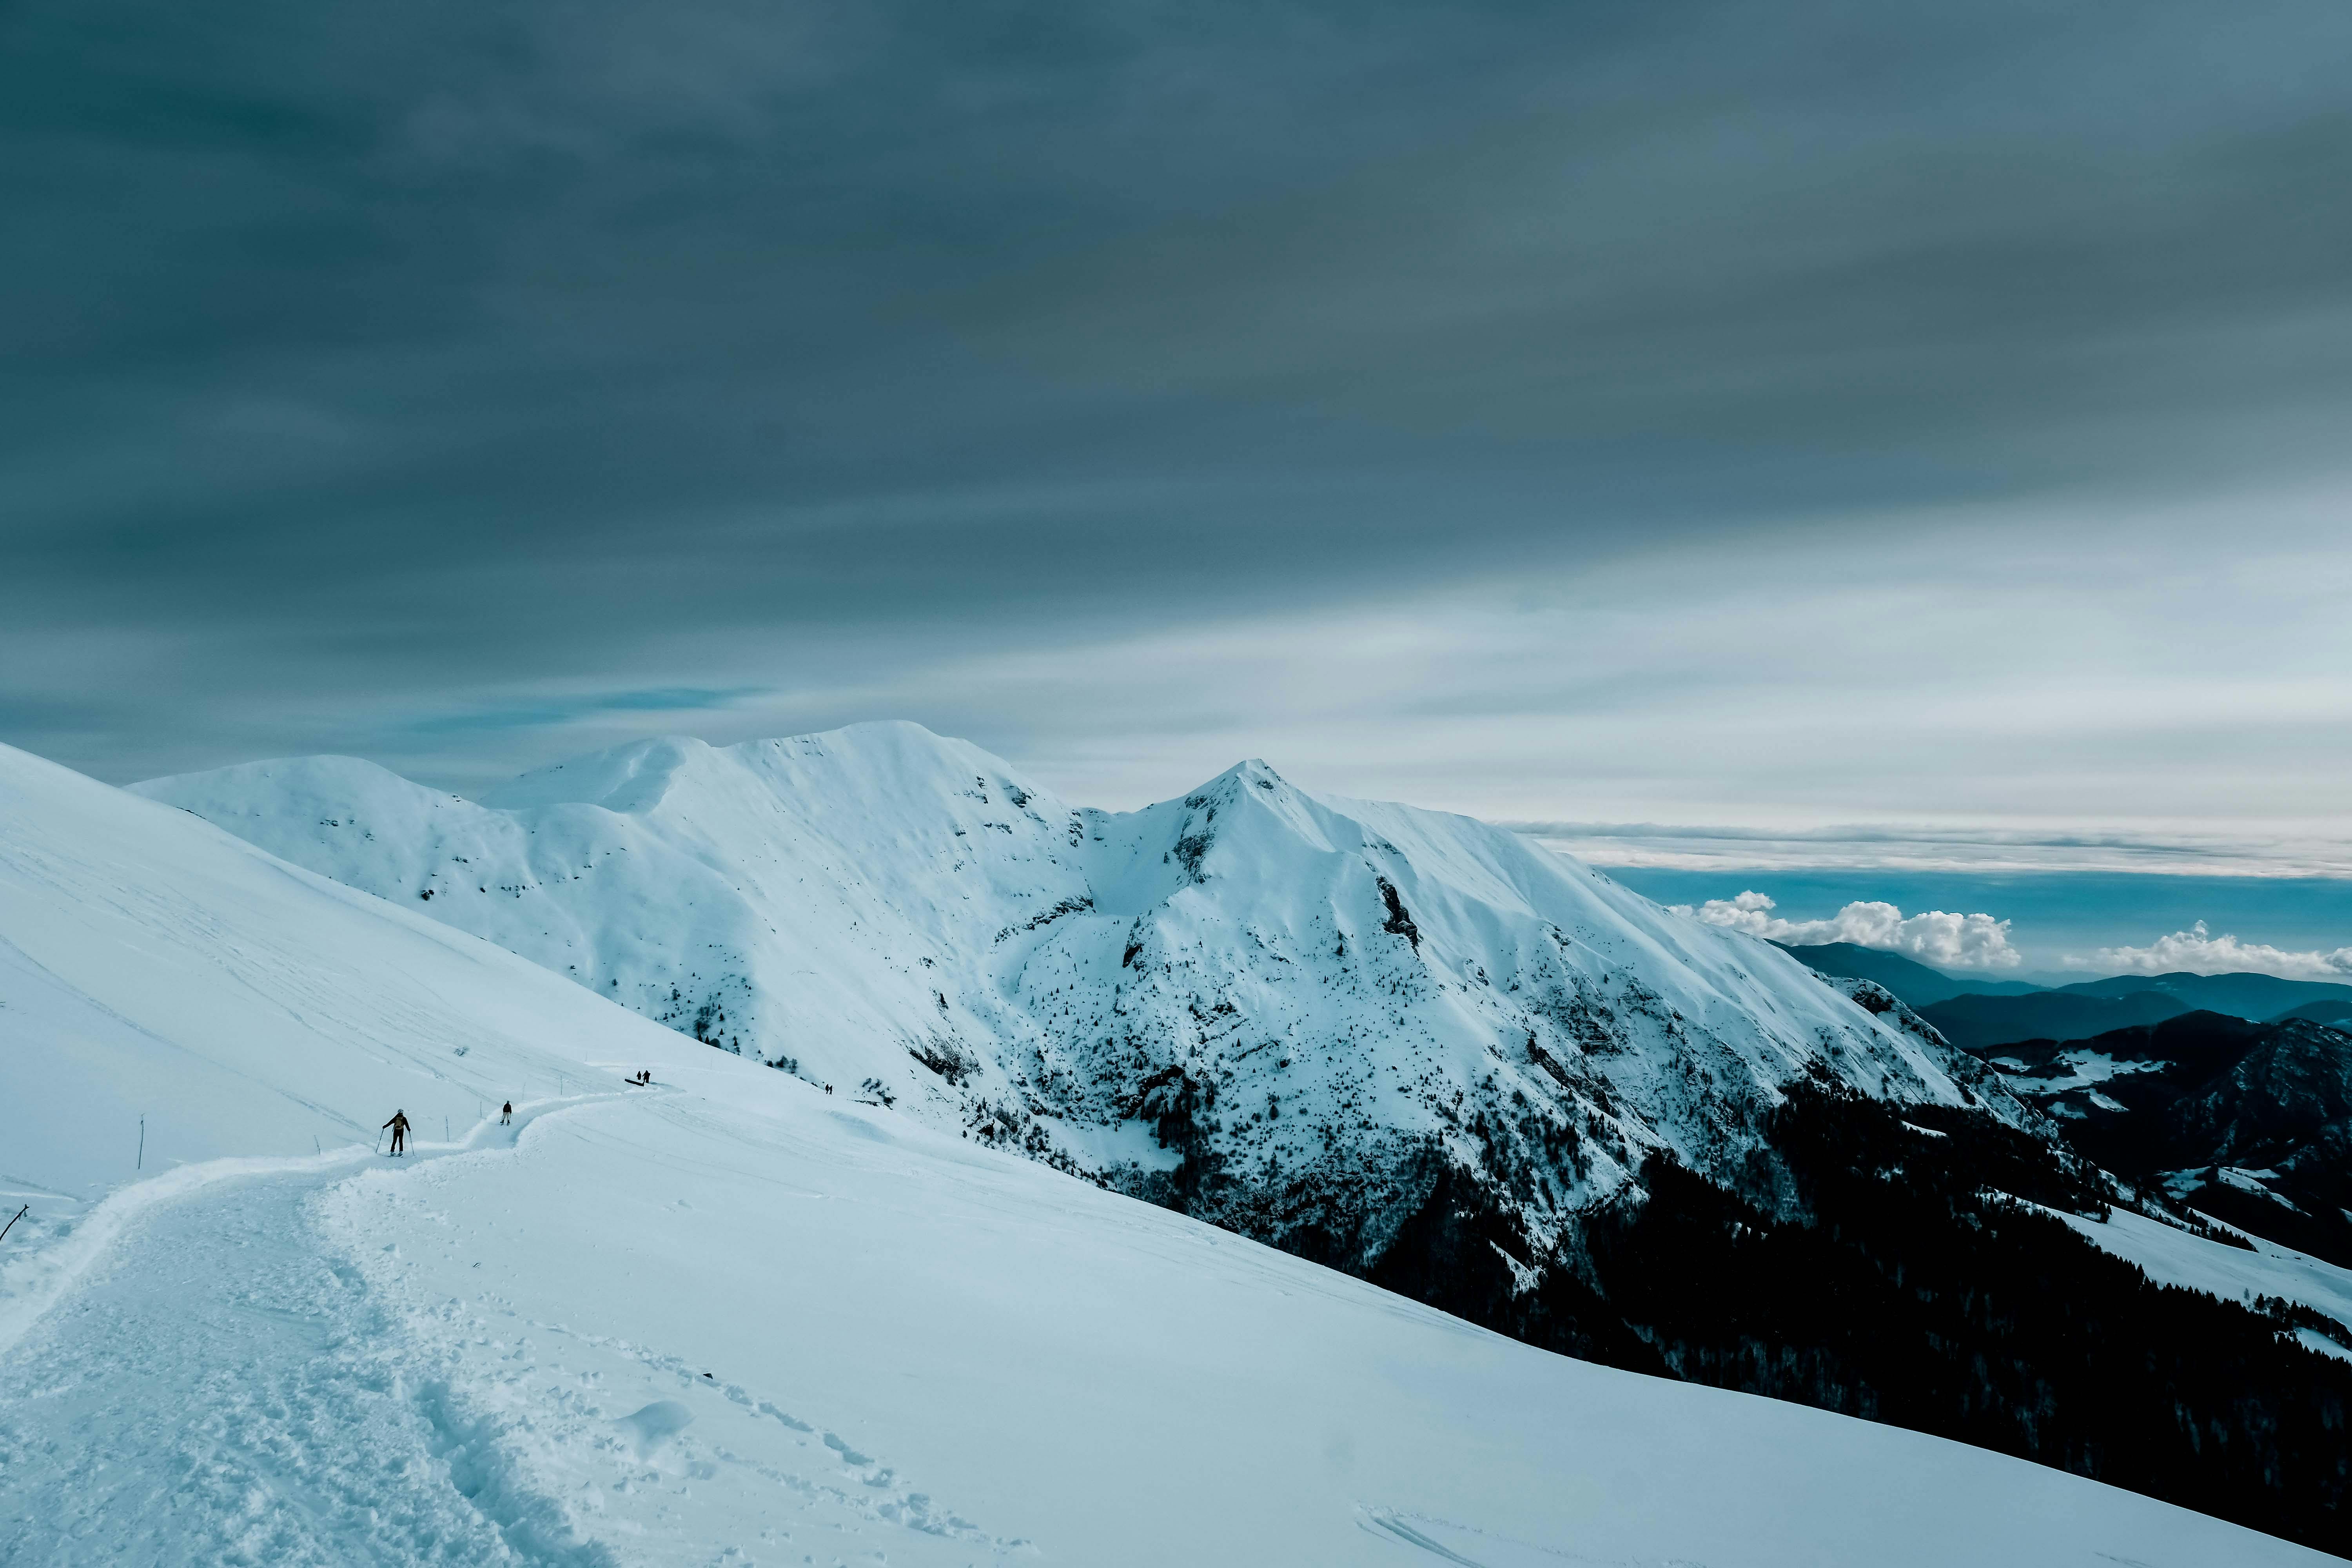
[136,724,2025,1267]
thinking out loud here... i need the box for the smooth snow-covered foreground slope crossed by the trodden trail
[0,748,2326,1568]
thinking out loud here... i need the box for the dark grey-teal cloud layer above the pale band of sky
[0,0,2352,778]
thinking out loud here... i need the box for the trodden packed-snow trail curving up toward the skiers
[0,1107,614,1568]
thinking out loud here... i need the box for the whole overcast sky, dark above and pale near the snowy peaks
[0,0,2352,936]
